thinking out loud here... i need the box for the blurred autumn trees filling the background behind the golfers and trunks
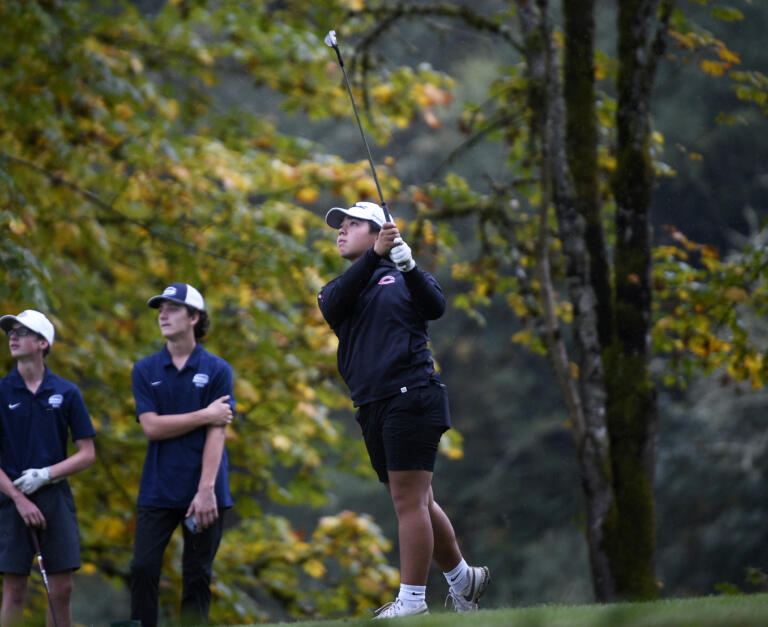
[0,0,768,622]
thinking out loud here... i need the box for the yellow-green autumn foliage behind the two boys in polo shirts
[0,0,447,623]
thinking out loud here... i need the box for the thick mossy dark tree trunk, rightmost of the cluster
[604,0,671,599]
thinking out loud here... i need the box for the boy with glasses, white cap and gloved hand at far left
[0,309,96,627]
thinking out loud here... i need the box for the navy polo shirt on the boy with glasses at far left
[0,366,96,481]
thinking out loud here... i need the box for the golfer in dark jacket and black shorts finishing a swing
[318,202,490,618]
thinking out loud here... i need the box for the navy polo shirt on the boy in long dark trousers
[132,344,235,508]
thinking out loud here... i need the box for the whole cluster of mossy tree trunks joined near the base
[517,0,671,601]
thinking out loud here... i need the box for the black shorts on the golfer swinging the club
[356,381,451,483]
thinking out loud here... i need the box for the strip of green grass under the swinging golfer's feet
[244,594,768,627]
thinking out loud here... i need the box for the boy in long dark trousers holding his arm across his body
[131,283,235,627]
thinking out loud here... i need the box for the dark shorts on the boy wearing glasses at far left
[0,481,80,575]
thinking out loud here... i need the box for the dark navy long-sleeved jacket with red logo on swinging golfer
[318,248,445,407]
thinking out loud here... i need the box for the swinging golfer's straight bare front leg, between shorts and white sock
[389,470,434,586]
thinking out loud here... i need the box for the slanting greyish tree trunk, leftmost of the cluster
[517,0,615,600]
